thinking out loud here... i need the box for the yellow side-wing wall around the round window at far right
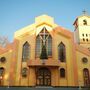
[76,51,90,86]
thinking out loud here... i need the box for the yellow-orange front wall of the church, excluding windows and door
[0,15,90,86]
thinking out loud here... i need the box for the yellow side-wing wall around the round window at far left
[0,50,12,86]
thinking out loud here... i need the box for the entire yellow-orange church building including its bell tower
[0,15,90,86]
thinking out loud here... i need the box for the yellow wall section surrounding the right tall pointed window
[53,31,74,86]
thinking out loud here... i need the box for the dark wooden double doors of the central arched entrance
[36,68,51,86]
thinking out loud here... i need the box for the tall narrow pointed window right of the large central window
[58,42,66,62]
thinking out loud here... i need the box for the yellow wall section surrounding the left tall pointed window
[16,32,35,85]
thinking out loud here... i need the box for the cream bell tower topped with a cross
[73,11,90,49]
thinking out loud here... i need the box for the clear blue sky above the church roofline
[0,0,90,42]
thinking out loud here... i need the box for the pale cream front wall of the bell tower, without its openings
[78,16,90,43]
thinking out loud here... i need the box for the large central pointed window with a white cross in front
[36,27,52,57]
